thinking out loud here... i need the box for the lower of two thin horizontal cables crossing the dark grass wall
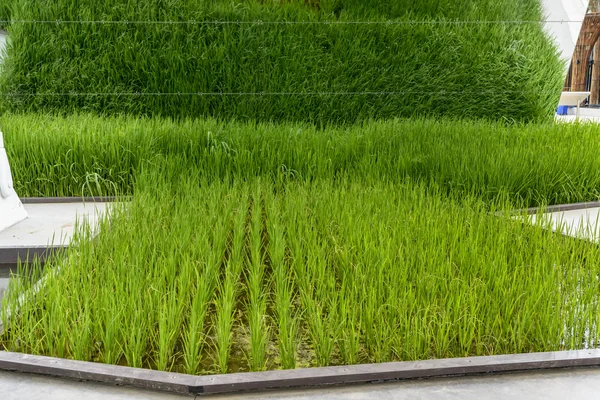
[0,90,560,97]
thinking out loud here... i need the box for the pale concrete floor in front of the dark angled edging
[0,368,600,400]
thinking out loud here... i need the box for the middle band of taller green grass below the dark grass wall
[0,114,600,206]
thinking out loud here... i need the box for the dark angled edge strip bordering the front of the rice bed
[0,349,600,394]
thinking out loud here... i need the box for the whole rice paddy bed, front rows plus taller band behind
[0,114,600,374]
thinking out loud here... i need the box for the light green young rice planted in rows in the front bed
[1,162,600,374]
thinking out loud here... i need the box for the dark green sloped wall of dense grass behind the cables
[0,0,563,125]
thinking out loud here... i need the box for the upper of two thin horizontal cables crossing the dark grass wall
[0,20,583,25]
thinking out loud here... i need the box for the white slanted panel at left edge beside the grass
[0,132,27,231]
